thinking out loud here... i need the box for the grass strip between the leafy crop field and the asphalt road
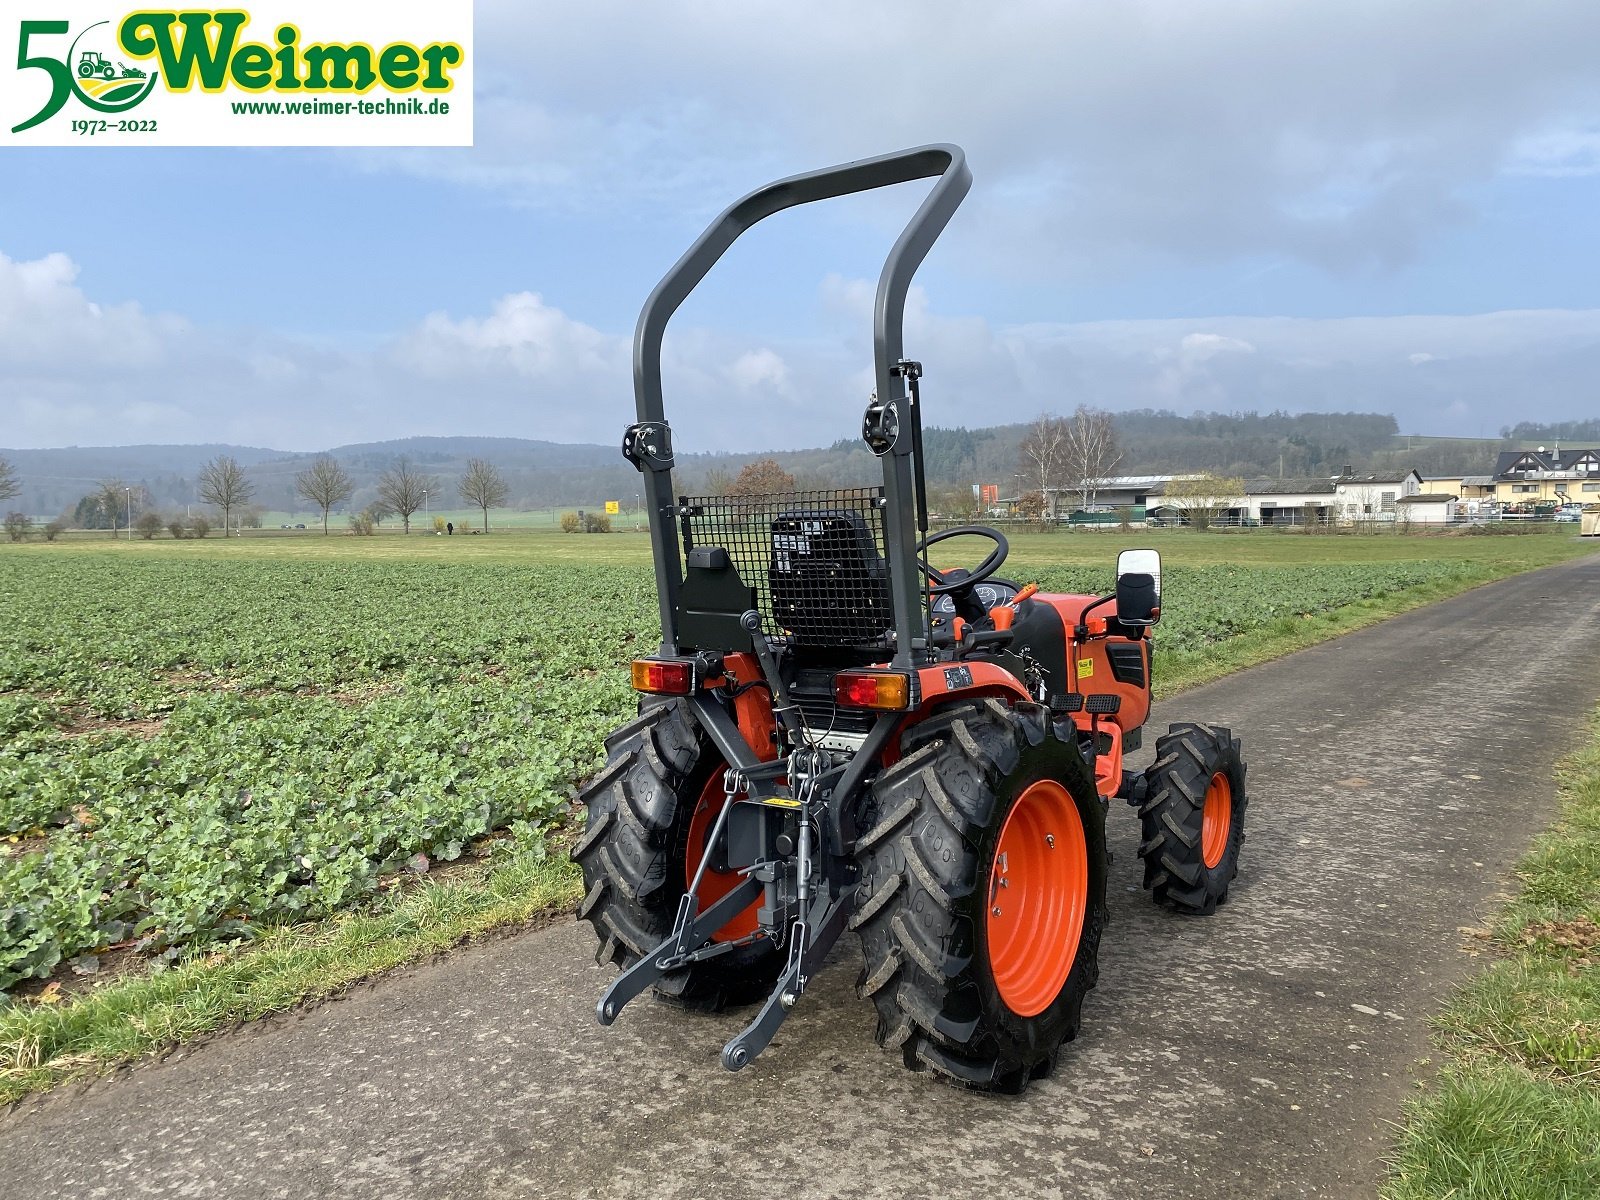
[0,538,1600,1107]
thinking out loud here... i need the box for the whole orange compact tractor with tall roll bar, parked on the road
[571,146,1245,1093]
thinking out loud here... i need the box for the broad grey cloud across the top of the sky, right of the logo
[363,0,1600,278]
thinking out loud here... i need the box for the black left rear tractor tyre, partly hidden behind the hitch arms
[571,698,782,1013]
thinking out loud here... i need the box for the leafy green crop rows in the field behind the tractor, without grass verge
[0,555,1470,994]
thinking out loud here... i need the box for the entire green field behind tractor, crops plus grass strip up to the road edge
[0,531,1589,1099]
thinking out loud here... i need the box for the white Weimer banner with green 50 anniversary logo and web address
[0,0,472,146]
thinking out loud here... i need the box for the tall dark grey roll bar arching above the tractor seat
[622,144,973,666]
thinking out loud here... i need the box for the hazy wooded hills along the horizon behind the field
[0,408,1555,517]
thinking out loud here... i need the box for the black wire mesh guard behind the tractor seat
[678,488,893,648]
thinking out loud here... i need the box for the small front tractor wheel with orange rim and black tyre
[1133,722,1245,915]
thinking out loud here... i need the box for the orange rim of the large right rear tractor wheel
[986,779,1090,1016]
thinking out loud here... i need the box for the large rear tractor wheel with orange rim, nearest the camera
[851,699,1107,1093]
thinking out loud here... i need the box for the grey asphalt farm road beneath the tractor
[0,557,1600,1200]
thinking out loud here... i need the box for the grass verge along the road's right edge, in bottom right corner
[1384,714,1600,1200]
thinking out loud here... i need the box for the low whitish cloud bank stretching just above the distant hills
[0,254,1600,451]
